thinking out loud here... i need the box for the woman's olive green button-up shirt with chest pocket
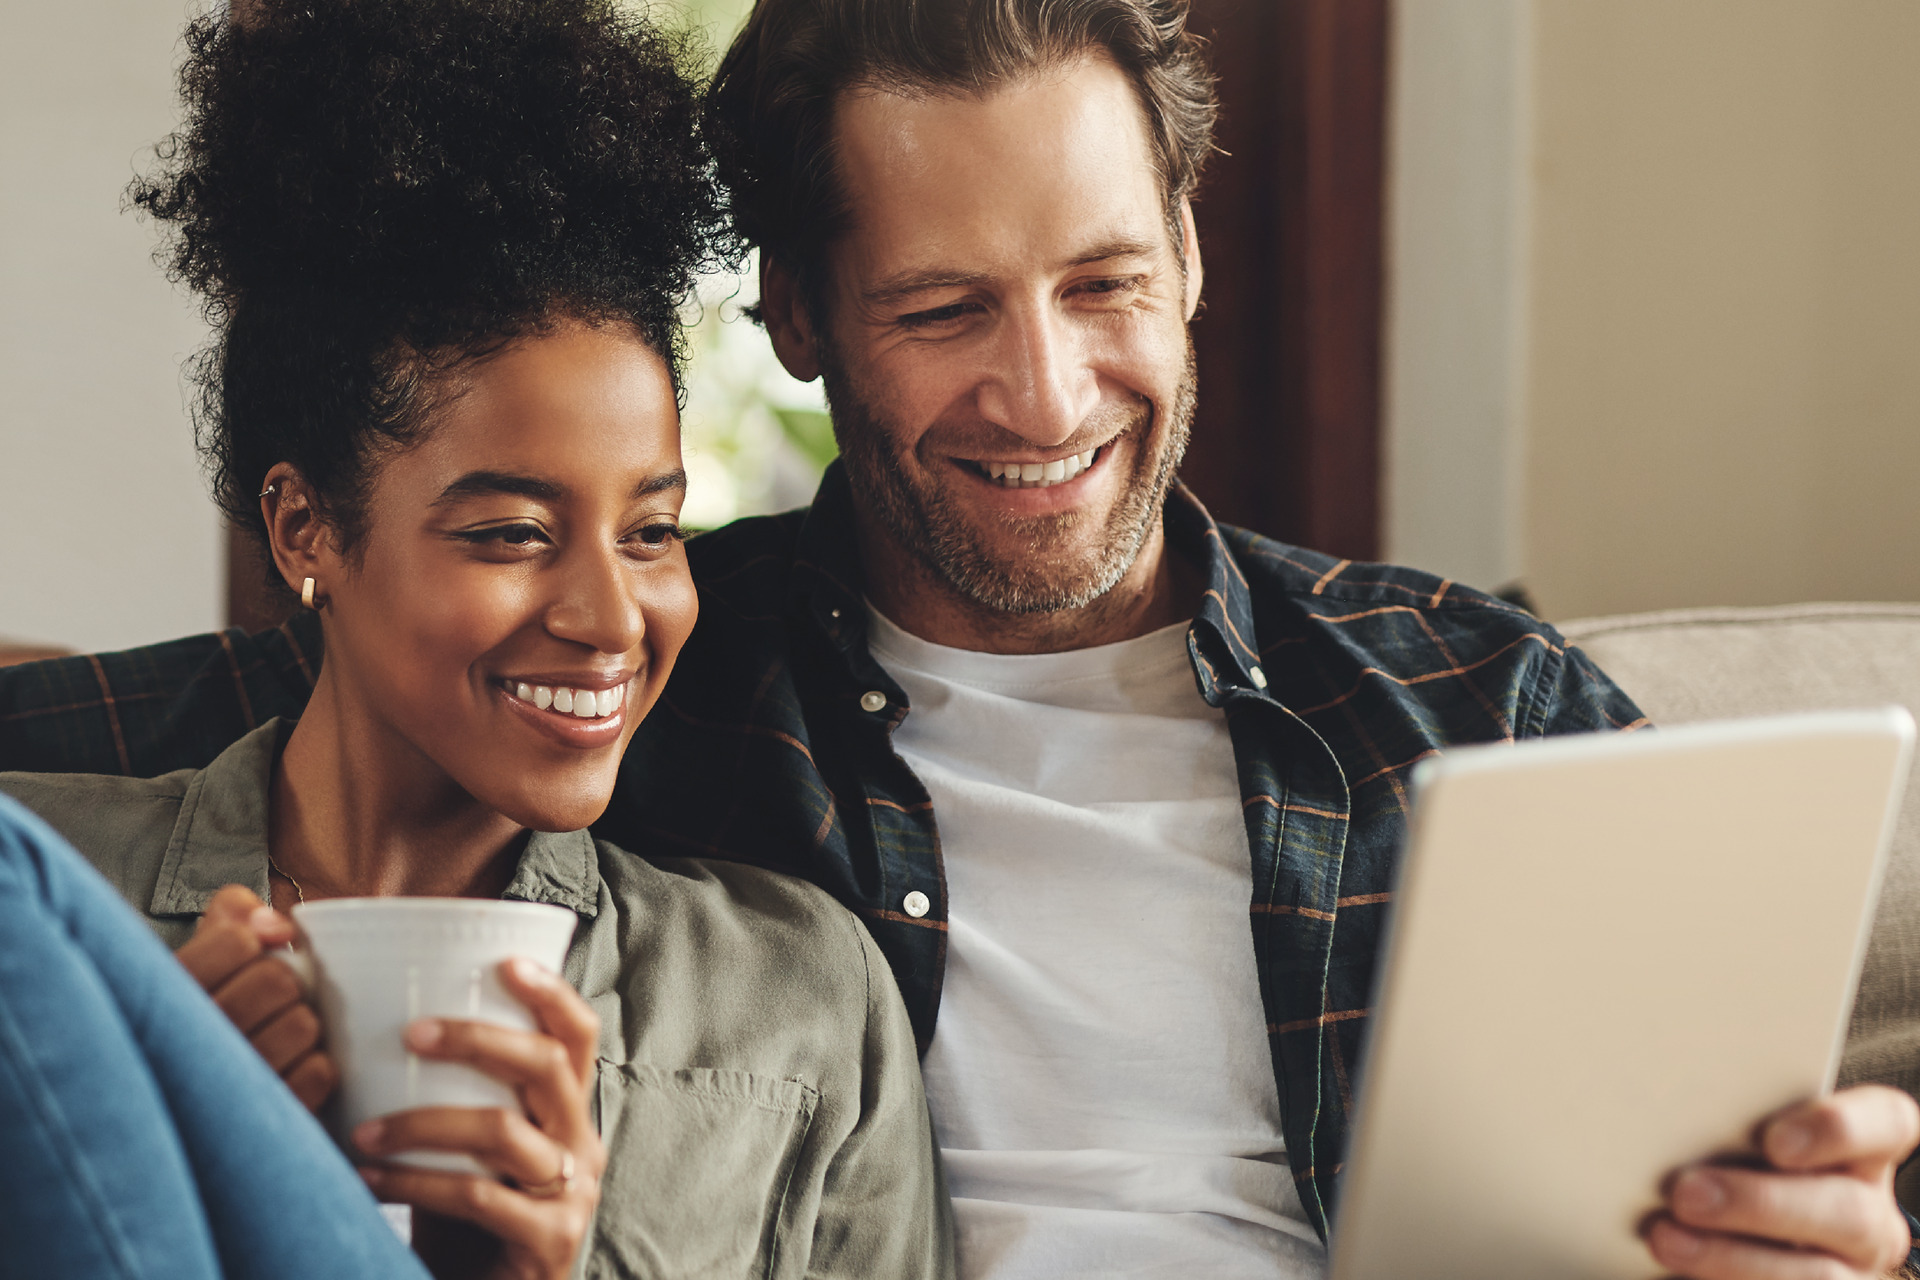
[0,720,952,1280]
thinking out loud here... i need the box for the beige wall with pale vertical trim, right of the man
[1386,0,1920,618]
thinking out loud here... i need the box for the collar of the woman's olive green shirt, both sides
[148,716,601,915]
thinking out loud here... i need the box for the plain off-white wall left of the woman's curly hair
[0,0,225,649]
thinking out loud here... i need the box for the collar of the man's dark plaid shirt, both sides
[787,461,1267,694]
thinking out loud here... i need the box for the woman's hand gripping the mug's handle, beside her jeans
[175,885,340,1111]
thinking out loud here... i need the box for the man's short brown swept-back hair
[707,0,1217,301]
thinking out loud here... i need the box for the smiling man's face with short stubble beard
[818,56,1198,614]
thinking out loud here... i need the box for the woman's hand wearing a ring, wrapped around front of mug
[353,960,607,1280]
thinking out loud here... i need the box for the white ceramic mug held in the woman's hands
[278,898,576,1176]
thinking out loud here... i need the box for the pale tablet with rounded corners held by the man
[1332,708,1914,1280]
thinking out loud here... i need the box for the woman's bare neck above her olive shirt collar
[267,668,528,898]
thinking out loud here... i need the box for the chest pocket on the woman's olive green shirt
[586,1059,820,1280]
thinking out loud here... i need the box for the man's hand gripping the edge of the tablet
[1647,1084,1920,1280]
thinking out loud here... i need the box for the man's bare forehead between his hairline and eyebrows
[835,56,1165,274]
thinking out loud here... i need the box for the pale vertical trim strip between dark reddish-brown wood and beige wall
[1382,0,1532,589]
